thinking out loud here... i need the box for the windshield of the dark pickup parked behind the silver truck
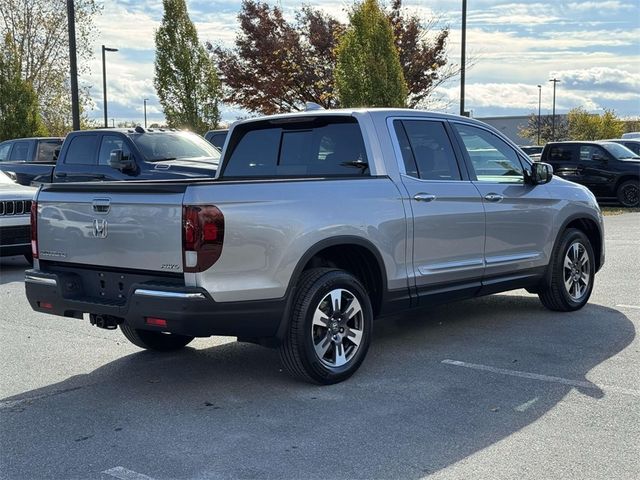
[131,132,220,164]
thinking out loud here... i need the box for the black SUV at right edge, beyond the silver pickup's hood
[541,142,640,207]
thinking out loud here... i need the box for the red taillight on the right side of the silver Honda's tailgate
[182,205,224,272]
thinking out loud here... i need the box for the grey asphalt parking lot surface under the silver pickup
[0,213,640,480]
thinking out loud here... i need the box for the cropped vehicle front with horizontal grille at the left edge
[0,172,37,261]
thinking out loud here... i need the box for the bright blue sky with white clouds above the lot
[81,0,640,124]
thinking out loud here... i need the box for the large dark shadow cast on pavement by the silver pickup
[0,295,635,479]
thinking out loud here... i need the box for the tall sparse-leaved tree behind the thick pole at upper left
[0,0,102,135]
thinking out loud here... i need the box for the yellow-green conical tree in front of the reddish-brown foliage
[335,0,408,107]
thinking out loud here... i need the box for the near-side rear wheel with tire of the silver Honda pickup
[280,268,373,385]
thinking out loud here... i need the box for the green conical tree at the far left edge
[0,34,44,142]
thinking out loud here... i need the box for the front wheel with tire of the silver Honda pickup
[538,228,595,312]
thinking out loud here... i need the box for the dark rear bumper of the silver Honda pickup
[25,270,285,338]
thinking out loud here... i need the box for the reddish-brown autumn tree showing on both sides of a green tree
[207,0,450,114]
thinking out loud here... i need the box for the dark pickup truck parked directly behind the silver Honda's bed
[0,127,220,185]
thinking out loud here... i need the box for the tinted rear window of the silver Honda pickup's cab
[223,117,370,178]
